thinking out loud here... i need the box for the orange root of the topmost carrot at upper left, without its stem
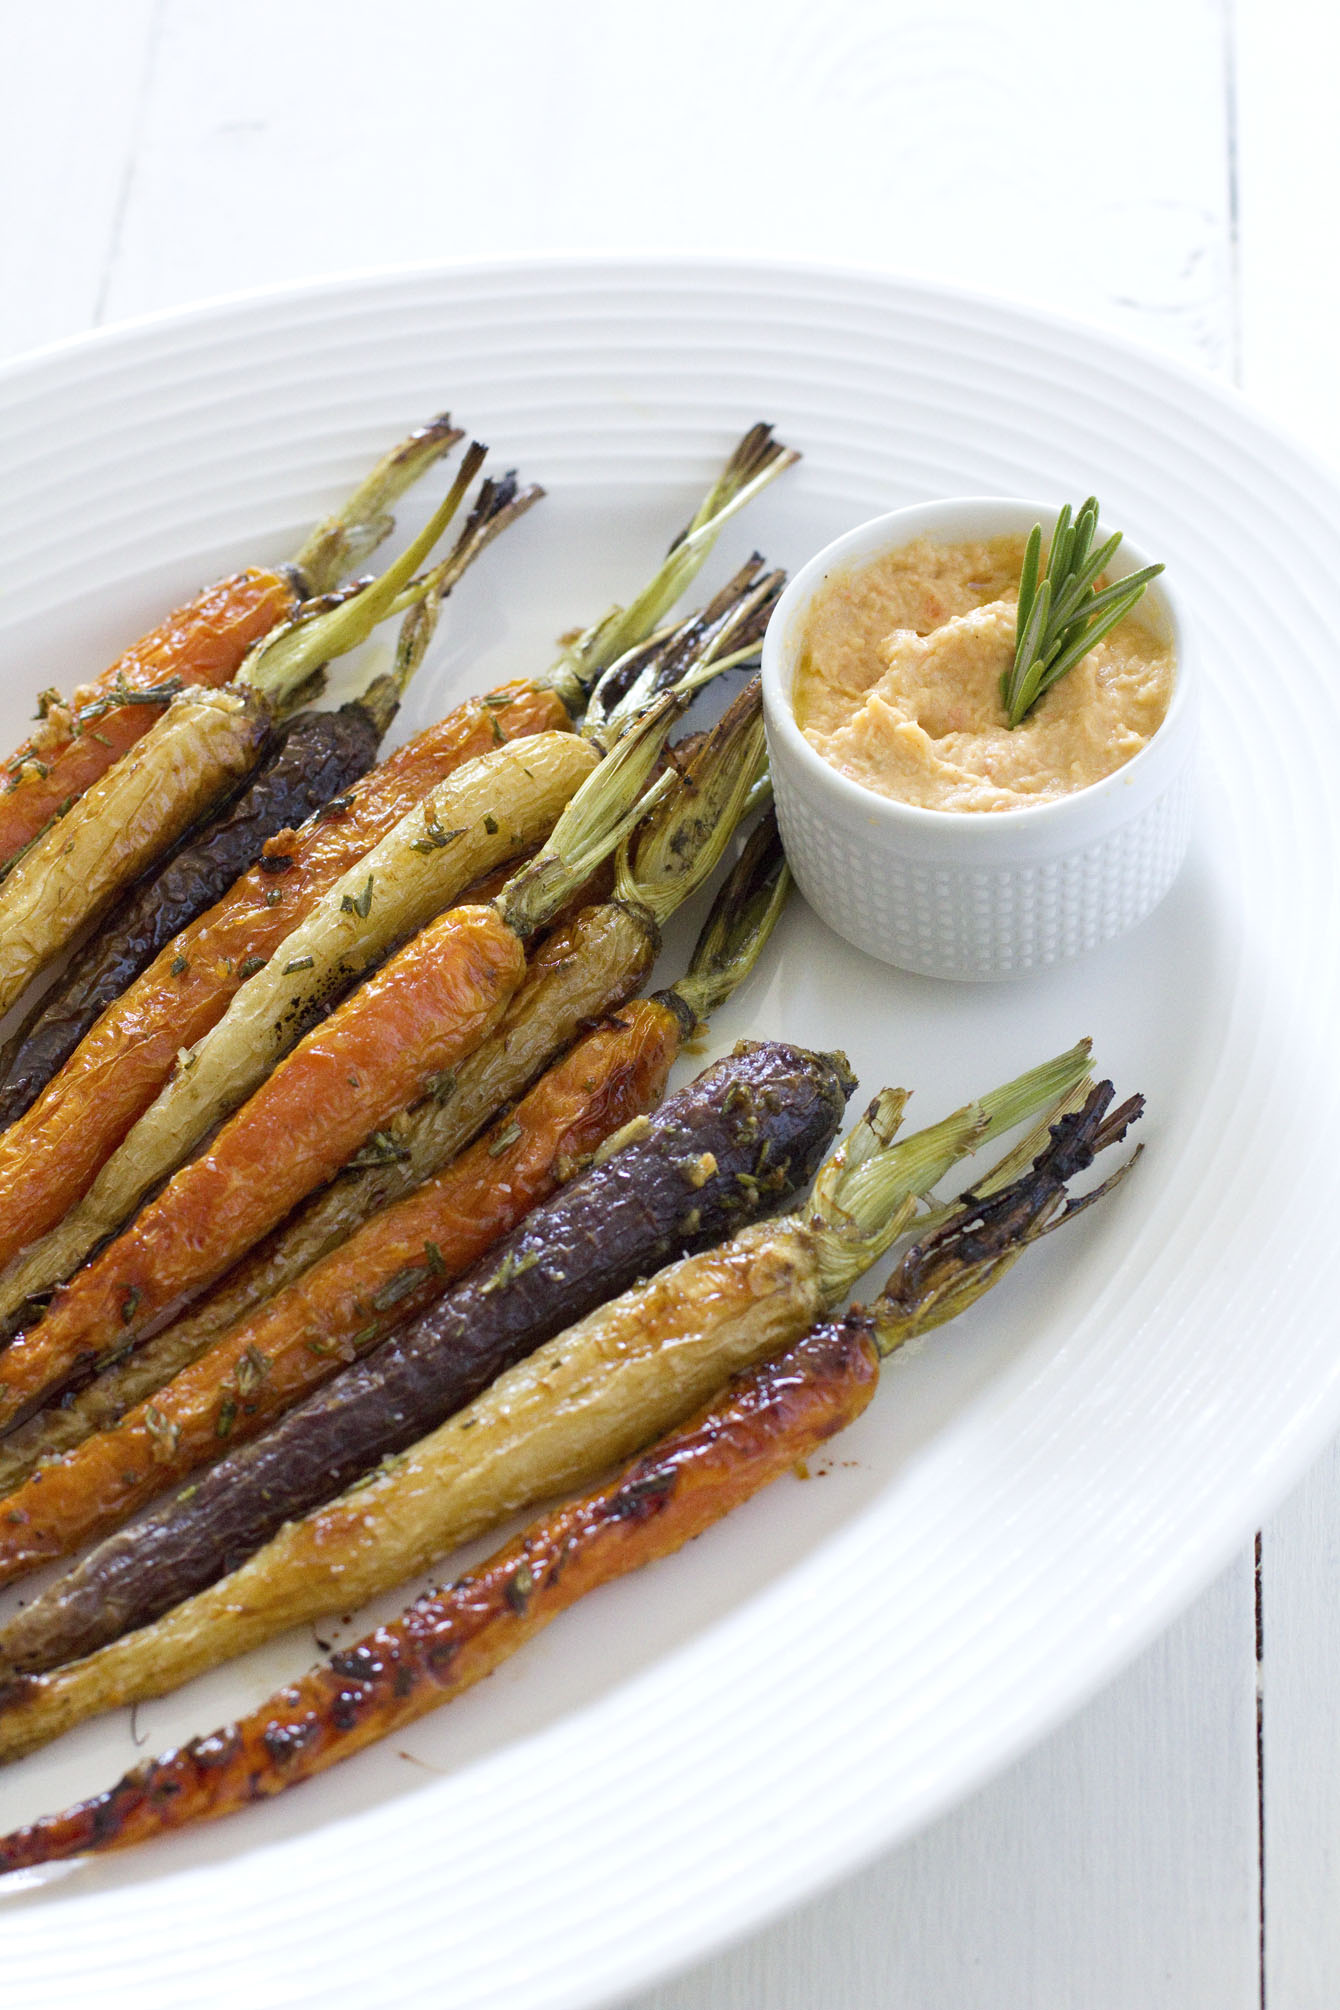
[0,567,297,866]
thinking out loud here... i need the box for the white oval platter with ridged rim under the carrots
[0,259,1340,2010]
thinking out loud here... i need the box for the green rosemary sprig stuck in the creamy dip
[1000,496,1163,728]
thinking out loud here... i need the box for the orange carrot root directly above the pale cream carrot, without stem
[0,681,571,1264]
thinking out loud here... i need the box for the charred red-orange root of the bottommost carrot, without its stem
[0,1313,878,1871]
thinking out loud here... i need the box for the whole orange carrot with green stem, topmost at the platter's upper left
[0,414,462,866]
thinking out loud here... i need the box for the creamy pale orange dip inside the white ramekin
[794,537,1175,810]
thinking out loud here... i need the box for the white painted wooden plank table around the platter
[0,0,1340,2010]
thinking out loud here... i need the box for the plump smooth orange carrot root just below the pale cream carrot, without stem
[0,907,526,1429]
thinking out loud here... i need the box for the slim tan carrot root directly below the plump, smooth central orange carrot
[0,892,657,1493]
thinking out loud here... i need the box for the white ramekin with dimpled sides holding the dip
[763,496,1197,979]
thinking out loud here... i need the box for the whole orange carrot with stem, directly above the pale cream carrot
[0,428,796,1294]
